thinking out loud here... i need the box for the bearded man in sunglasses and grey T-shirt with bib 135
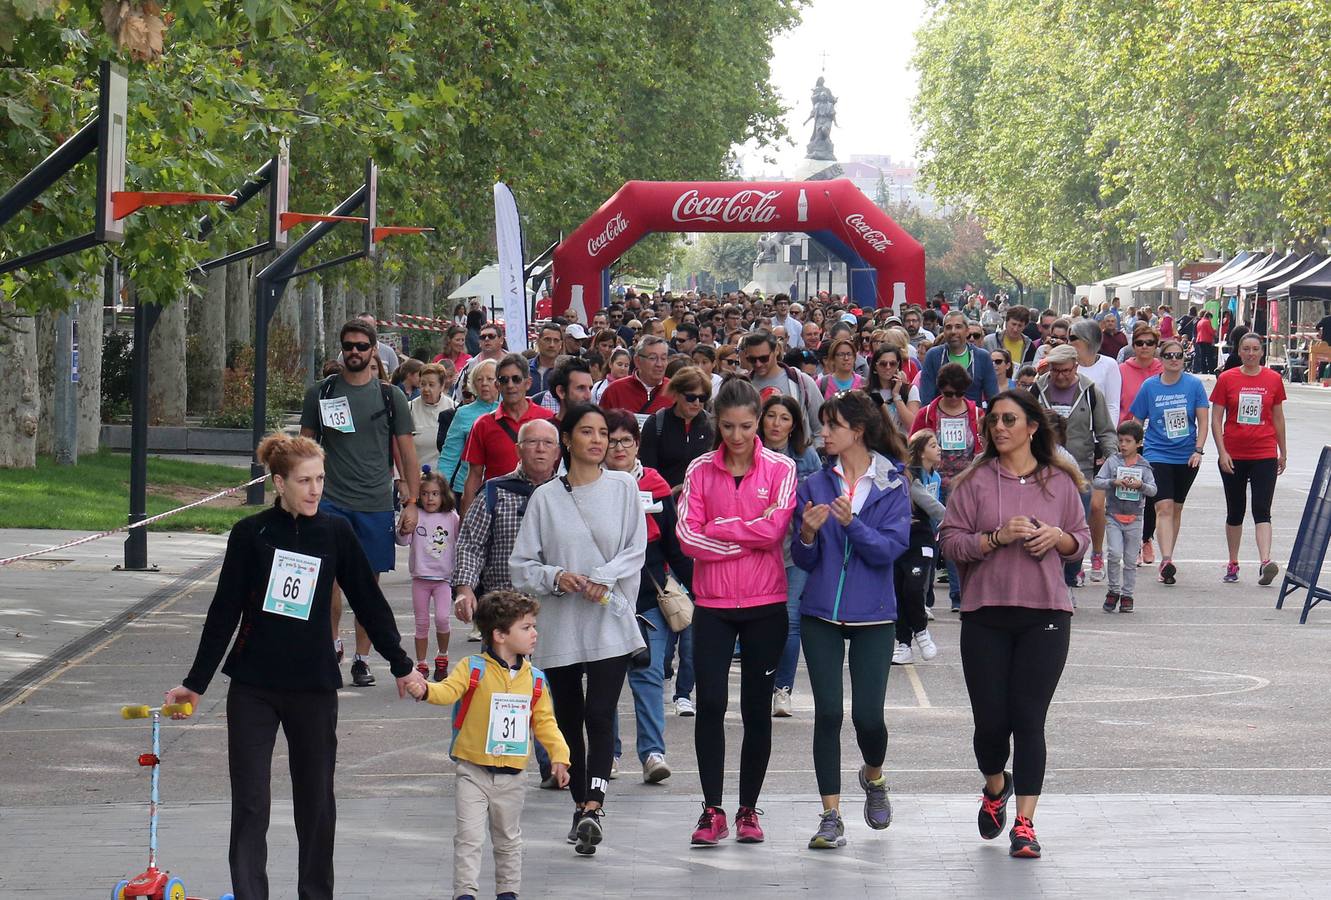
[301,320,421,687]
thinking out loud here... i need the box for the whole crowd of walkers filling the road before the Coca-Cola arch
[168,292,1287,900]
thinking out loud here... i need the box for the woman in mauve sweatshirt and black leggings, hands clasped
[940,390,1090,857]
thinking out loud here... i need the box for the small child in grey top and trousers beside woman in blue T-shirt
[1093,419,1155,612]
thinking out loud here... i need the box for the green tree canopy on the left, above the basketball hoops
[0,0,804,309]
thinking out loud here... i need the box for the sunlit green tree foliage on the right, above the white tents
[914,0,1331,281]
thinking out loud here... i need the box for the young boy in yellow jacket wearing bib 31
[407,591,568,900]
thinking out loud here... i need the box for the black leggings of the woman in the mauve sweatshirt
[961,606,1073,796]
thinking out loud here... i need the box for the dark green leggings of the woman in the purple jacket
[800,615,893,796]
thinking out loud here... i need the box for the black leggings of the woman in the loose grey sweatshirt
[546,656,628,805]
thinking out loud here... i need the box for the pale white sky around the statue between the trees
[740,0,926,178]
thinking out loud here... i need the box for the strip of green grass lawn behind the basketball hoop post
[0,449,257,529]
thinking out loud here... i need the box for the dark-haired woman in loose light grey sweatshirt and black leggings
[508,405,647,856]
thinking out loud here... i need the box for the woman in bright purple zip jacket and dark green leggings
[791,390,910,849]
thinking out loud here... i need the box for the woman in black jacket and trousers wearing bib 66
[166,434,423,900]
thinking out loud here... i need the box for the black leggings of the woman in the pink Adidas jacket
[693,602,789,807]
